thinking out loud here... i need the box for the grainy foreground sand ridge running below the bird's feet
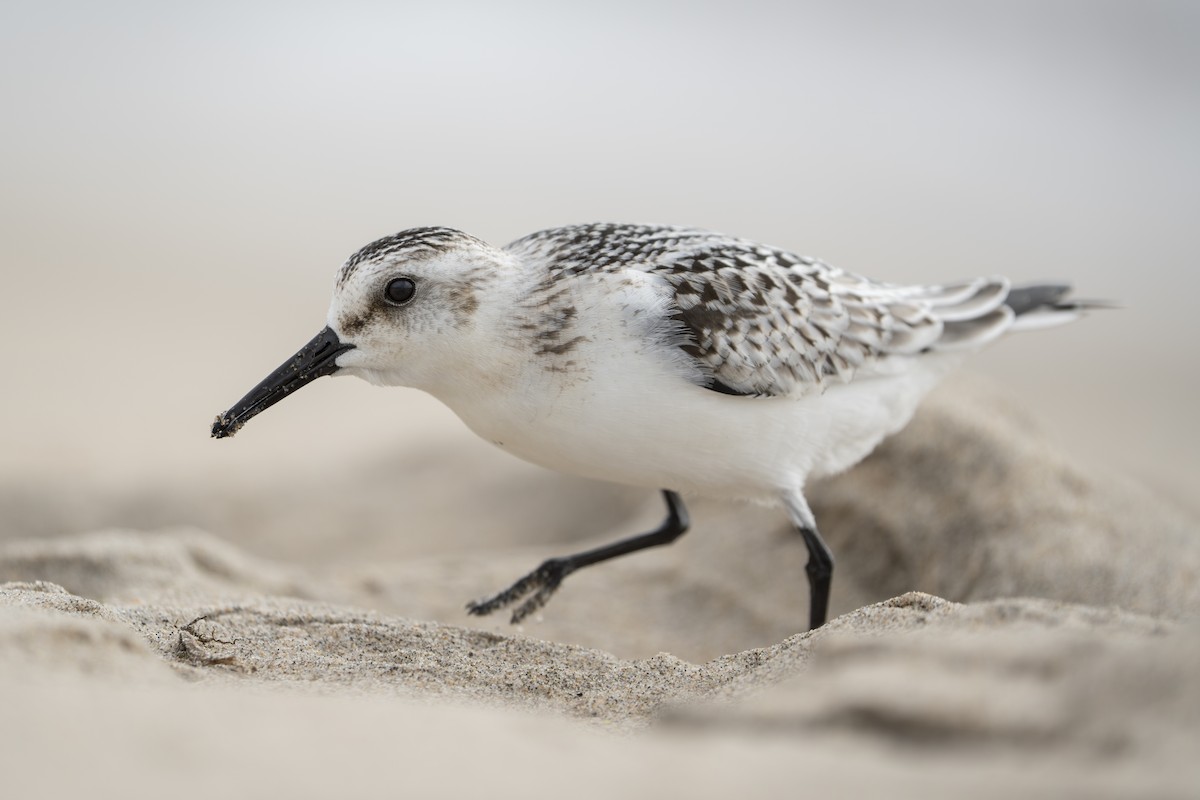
[0,573,1200,798]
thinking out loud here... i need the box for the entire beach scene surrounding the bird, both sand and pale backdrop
[0,0,1200,800]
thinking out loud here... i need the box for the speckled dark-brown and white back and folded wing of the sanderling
[509,224,1013,396]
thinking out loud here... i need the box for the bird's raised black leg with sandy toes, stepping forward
[467,489,696,625]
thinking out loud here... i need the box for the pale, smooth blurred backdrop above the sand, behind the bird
[0,0,1200,536]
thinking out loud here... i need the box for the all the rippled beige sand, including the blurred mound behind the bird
[0,380,1200,798]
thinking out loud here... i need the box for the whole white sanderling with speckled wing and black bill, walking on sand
[212,224,1091,627]
